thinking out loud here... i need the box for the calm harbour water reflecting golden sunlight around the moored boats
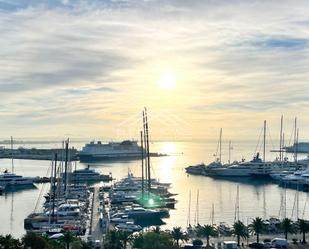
[0,142,309,236]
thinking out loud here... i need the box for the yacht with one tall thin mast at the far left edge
[0,137,36,189]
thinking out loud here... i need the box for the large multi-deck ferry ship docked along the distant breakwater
[79,140,146,162]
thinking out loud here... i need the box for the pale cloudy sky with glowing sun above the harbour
[0,0,309,140]
